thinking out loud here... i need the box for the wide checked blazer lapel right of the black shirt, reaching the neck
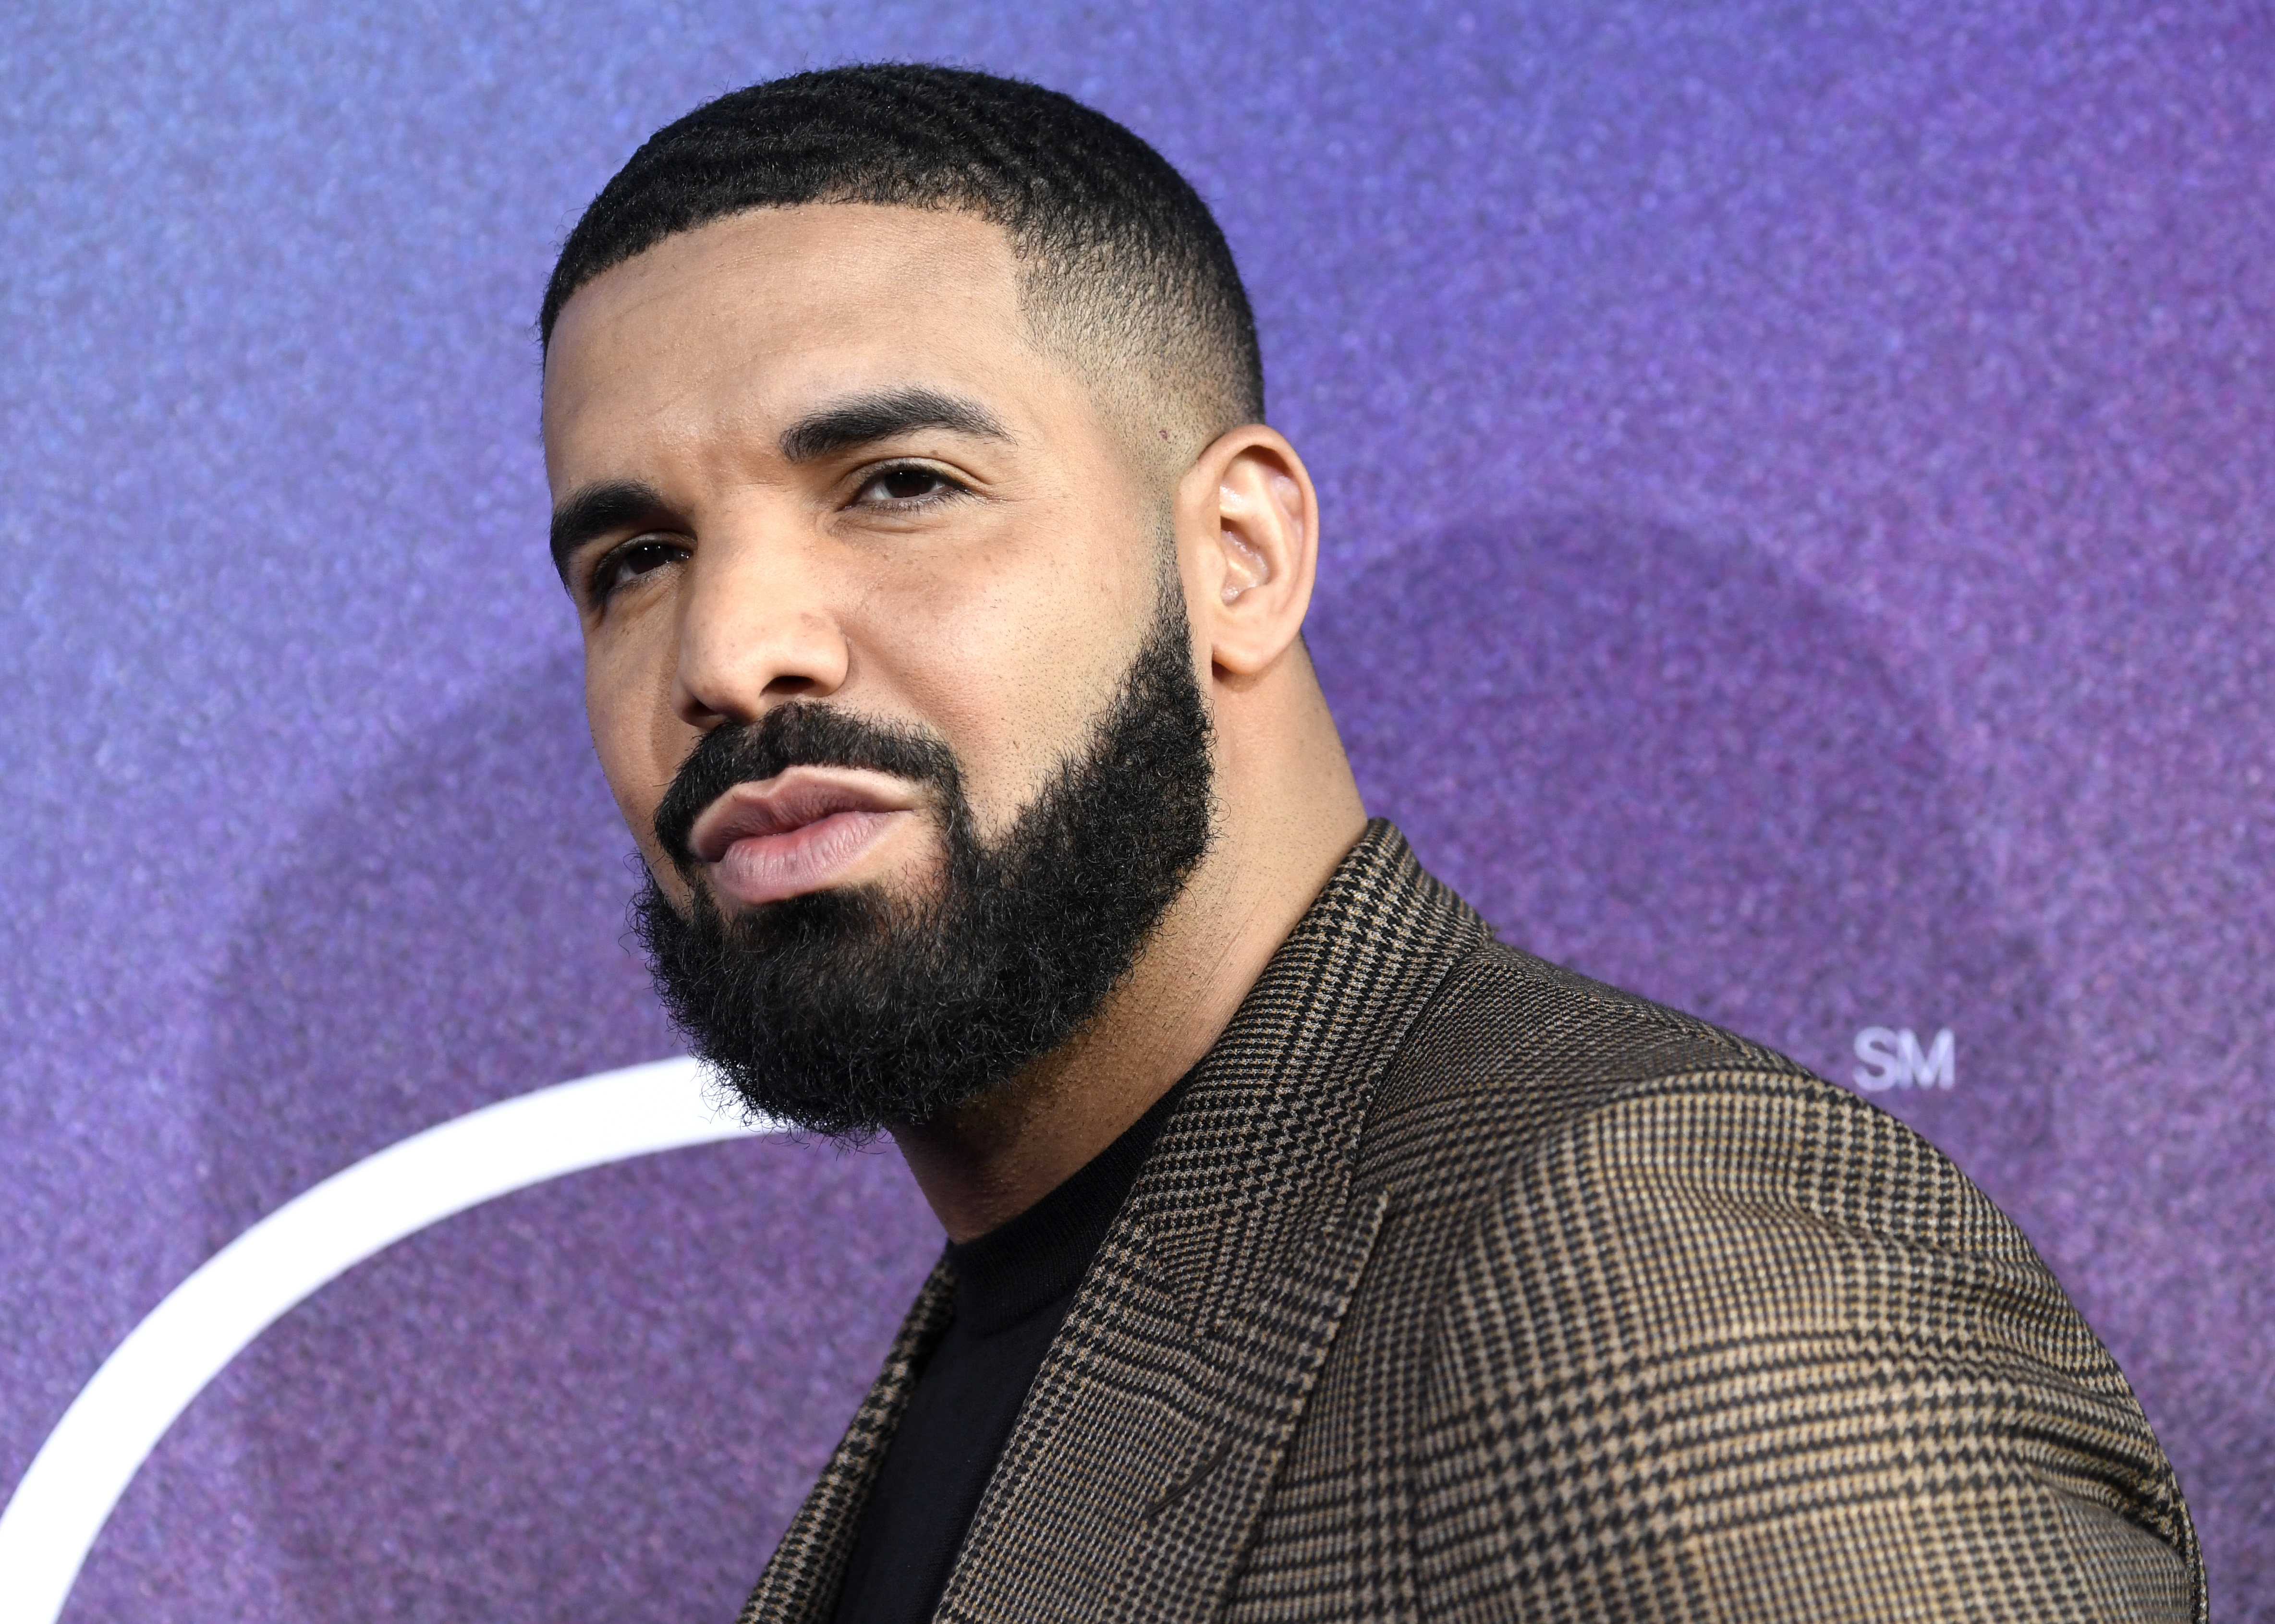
[928,824,1490,1624]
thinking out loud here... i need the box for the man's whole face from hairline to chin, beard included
[546,207,1210,1133]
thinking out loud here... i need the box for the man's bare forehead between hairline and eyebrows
[544,203,1042,478]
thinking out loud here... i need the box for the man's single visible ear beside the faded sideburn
[1176,423,1319,680]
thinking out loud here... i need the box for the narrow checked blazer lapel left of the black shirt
[740,1258,956,1624]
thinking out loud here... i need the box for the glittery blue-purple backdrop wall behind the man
[0,0,2275,1624]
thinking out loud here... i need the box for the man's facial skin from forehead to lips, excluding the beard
[544,205,1160,896]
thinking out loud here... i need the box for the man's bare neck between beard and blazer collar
[892,668,1365,1242]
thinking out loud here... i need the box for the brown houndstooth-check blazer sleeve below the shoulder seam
[1413,1071,2207,1624]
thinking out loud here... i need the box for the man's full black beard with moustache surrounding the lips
[633,587,1213,1139]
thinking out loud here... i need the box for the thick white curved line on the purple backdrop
[0,1058,769,1624]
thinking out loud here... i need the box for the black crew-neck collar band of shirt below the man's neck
[949,1080,1185,1337]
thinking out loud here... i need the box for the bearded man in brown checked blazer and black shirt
[541,66,2204,1622]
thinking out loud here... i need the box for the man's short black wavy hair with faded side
[537,64,1265,436]
